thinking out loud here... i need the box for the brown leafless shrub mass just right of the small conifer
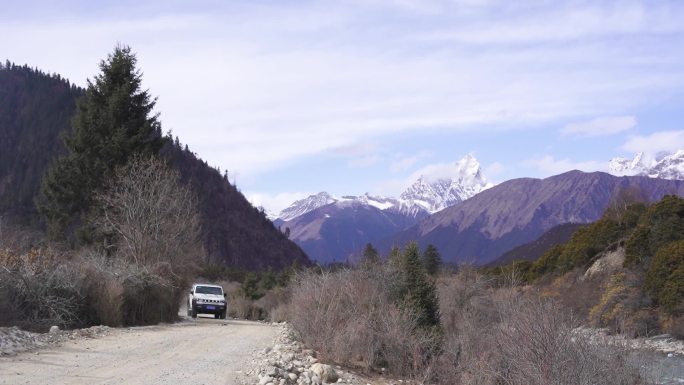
[434,270,647,385]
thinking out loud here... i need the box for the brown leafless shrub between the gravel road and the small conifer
[290,267,436,376]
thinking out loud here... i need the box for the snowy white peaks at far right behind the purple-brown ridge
[608,150,684,180]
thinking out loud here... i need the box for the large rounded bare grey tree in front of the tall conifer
[95,157,203,275]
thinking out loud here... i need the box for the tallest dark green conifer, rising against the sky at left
[37,46,164,236]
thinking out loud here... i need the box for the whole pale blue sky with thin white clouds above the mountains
[0,0,684,210]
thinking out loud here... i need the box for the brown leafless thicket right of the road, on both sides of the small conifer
[290,267,648,385]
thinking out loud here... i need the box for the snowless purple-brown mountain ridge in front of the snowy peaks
[376,171,684,264]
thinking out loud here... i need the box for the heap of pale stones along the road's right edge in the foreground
[241,323,367,385]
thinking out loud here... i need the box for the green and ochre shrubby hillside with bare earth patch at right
[485,195,684,336]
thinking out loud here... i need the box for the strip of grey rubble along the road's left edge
[0,326,111,356]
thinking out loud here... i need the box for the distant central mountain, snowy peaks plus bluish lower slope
[274,155,492,263]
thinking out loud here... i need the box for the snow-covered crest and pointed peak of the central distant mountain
[278,155,492,222]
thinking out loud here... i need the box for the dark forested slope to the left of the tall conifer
[0,62,84,220]
